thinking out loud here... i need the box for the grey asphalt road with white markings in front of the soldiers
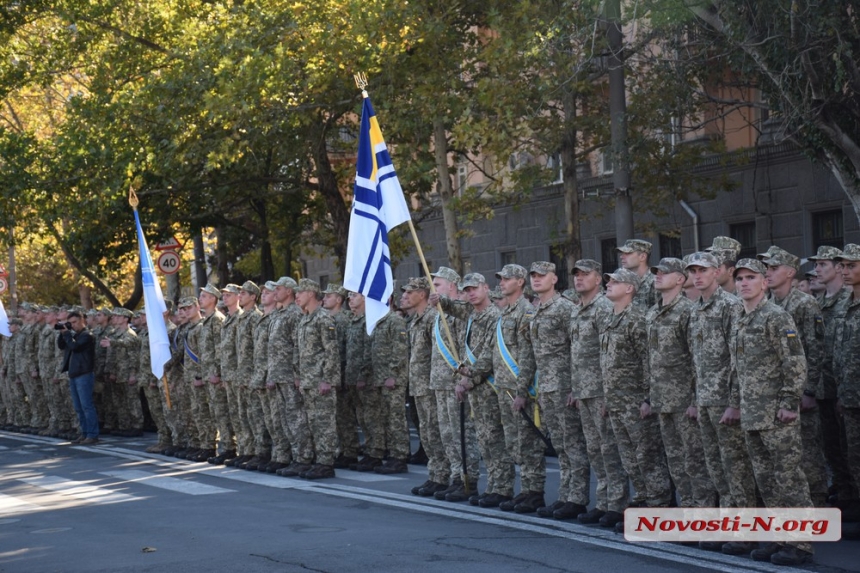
[0,432,860,573]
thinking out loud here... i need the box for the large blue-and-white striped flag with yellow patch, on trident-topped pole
[343,95,410,334]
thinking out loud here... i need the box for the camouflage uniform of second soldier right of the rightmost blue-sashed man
[570,293,630,513]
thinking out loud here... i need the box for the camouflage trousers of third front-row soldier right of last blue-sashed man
[609,404,672,507]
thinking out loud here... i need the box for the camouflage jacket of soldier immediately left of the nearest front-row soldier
[690,288,743,408]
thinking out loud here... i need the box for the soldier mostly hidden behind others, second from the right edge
[809,246,860,510]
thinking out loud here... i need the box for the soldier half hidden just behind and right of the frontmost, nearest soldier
[759,247,827,507]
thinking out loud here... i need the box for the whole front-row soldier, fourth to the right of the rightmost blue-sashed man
[640,258,716,507]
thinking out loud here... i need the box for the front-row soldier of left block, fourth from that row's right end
[224,281,262,467]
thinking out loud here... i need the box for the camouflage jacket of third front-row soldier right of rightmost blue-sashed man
[600,303,650,410]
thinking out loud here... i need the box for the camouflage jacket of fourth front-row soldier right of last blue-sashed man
[645,293,696,414]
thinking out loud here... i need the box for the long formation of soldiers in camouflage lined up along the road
[0,237,860,565]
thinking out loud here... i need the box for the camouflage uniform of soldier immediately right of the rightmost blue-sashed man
[531,293,591,506]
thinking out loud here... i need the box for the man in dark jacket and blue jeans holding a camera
[57,311,99,445]
